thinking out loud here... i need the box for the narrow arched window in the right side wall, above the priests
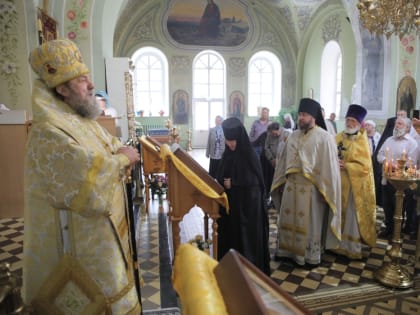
[320,41,342,118]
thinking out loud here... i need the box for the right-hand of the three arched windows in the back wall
[248,51,281,116]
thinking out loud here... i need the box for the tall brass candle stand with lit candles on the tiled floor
[375,159,420,289]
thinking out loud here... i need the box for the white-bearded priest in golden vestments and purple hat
[334,104,376,259]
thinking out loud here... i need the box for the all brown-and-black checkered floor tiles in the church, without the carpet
[0,201,420,314]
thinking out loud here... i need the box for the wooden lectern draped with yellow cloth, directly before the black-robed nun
[164,145,228,259]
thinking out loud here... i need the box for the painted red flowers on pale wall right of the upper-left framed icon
[66,0,91,42]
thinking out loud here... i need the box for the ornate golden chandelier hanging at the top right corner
[357,0,420,39]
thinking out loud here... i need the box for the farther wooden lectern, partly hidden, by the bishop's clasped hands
[140,136,166,213]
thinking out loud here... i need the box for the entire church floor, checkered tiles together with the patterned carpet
[0,151,420,314]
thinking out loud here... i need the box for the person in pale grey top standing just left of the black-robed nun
[206,115,225,177]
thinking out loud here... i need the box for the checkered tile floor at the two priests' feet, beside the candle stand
[269,209,419,296]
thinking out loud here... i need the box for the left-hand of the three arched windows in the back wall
[131,47,169,116]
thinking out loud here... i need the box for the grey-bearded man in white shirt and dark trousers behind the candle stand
[377,117,419,238]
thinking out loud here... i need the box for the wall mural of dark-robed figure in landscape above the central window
[164,0,250,47]
